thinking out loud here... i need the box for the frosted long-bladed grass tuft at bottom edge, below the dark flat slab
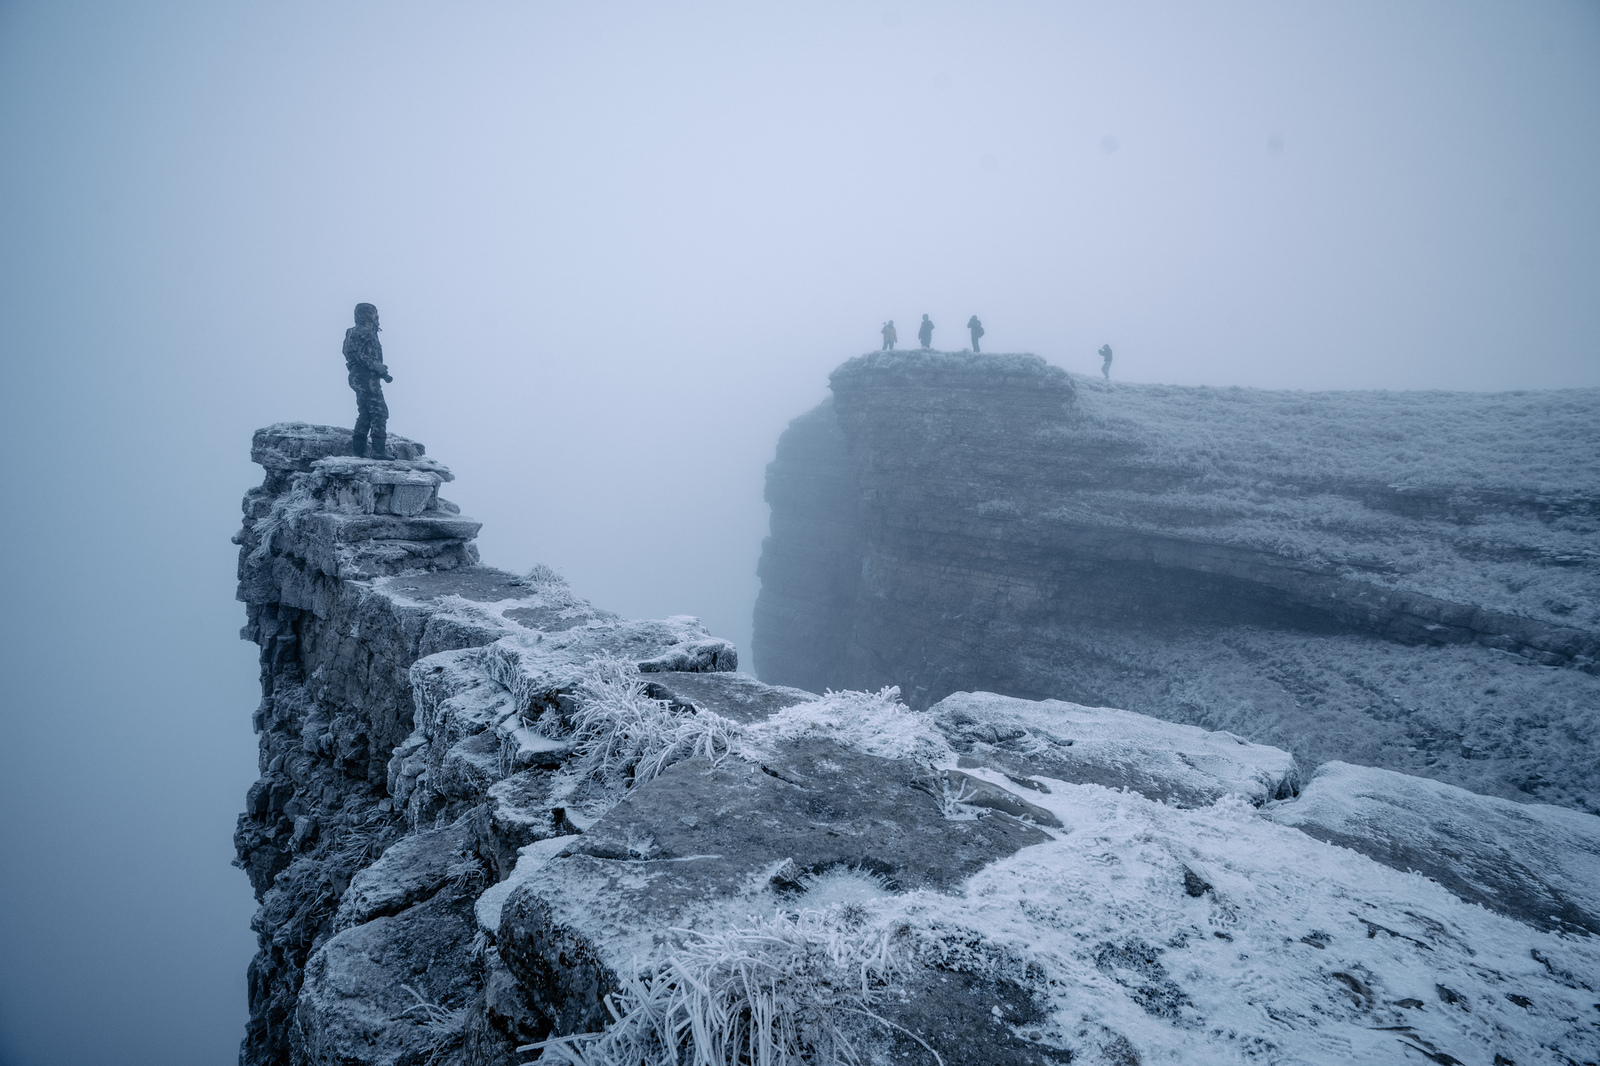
[518,909,942,1066]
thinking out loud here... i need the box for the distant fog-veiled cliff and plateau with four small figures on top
[754,352,1600,810]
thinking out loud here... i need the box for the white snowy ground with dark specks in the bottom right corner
[915,771,1600,1066]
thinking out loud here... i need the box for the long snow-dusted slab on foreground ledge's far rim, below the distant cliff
[928,691,1299,807]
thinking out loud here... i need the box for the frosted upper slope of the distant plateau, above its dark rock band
[1056,378,1600,629]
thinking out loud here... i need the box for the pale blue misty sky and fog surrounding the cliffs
[0,0,1600,1066]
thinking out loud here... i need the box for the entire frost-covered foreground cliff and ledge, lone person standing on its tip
[237,416,1600,1066]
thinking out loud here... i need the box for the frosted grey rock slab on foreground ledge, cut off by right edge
[1269,762,1600,935]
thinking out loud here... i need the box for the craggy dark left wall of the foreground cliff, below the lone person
[235,423,733,1063]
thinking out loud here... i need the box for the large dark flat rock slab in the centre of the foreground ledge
[498,738,1051,1032]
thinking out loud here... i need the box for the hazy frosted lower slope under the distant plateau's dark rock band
[1024,626,1600,813]
